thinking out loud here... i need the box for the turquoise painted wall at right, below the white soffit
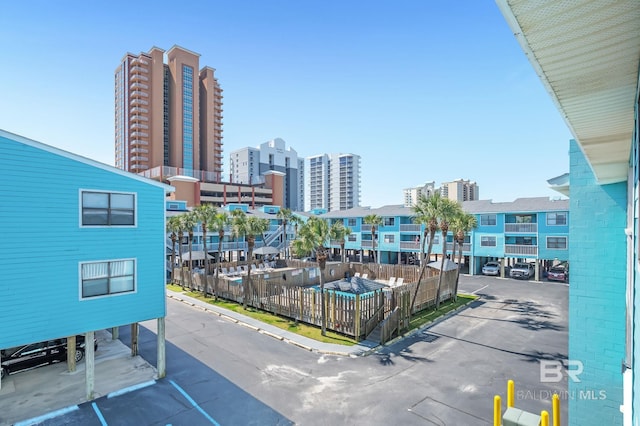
[569,141,627,425]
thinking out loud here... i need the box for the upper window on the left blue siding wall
[82,191,136,226]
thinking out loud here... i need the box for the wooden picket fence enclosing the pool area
[174,263,456,343]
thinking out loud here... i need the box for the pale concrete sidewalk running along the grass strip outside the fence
[167,289,379,357]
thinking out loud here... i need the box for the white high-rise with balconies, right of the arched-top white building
[304,154,360,211]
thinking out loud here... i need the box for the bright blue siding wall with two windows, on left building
[0,135,166,347]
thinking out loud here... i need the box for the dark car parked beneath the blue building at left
[0,335,98,377]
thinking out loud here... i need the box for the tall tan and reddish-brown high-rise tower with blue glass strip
[115,46,223,182]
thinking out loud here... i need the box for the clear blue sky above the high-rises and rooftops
[0,0,572,207]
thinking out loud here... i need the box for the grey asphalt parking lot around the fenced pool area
[0,276,568,426]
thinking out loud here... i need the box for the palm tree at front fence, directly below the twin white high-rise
[293,217,329,336]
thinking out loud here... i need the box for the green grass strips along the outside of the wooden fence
[167,284,476,346]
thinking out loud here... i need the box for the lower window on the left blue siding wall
[80,259,136,299]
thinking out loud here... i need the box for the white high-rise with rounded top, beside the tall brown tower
[229,138,304,211]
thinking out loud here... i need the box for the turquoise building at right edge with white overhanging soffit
[497,0,640,425]
